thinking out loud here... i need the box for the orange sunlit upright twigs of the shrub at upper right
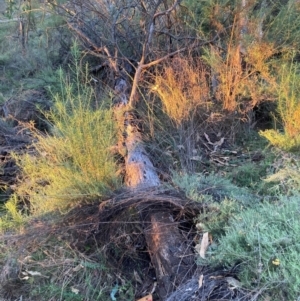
[203,41,276,113]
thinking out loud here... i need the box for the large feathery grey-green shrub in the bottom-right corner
[210,195,300,300]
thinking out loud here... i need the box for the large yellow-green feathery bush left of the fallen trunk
[7,68,120,214]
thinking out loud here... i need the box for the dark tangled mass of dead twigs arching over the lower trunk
[0,189,251,301]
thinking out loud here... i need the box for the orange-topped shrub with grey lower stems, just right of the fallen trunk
[151,56,213,172]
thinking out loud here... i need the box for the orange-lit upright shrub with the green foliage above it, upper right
[182,0,300,115]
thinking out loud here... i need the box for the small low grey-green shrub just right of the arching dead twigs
[173,174,256,238]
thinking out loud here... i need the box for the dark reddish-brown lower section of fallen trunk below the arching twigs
[143,209,195,300]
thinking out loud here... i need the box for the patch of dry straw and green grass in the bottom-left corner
[0,213,115,301]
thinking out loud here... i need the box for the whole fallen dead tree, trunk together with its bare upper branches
[47,0,210,300]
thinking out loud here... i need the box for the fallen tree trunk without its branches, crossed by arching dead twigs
[114,74,194,300]
